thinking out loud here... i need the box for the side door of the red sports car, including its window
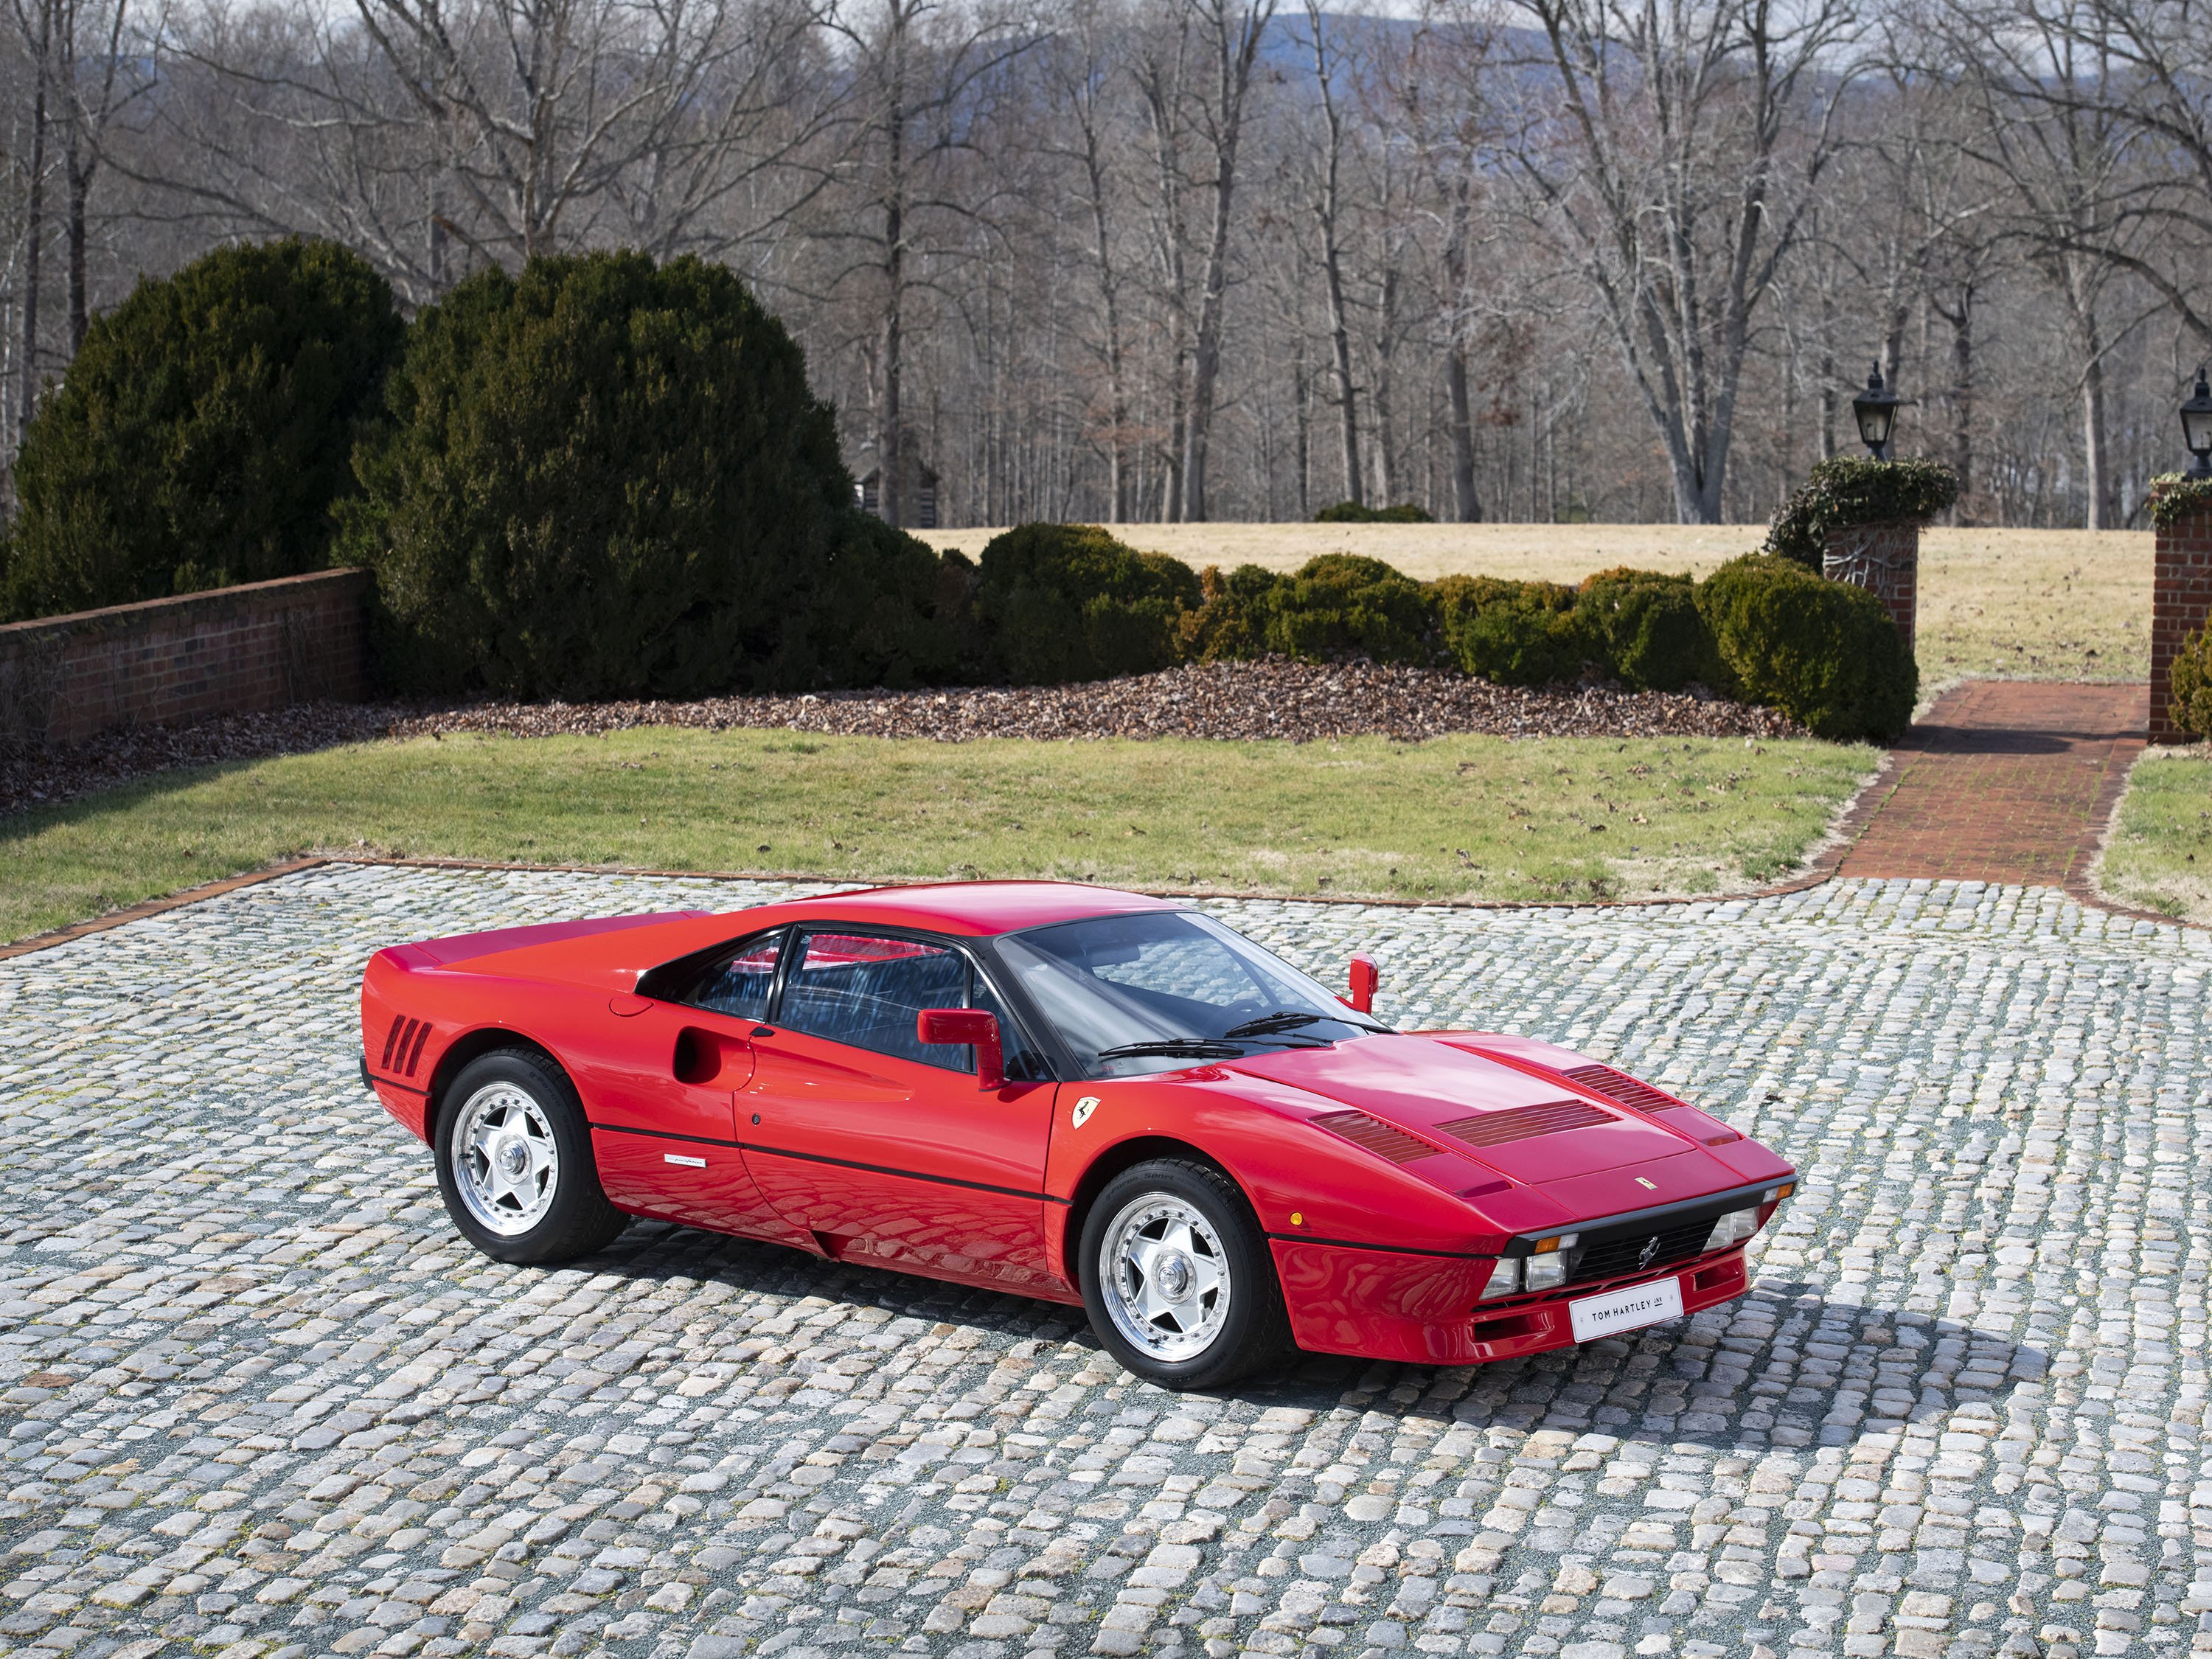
[739,927,1053,1290]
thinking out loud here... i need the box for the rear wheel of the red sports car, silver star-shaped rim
[431,1048,630,1263]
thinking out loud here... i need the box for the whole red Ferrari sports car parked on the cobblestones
[361,883,1796,1387]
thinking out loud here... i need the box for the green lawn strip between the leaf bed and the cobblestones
[0,728,1876,938]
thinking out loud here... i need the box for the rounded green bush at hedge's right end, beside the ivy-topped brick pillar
[1697,553,1920,741]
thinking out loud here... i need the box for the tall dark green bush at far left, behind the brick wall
[0,239,403,617]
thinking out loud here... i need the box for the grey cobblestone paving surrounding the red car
[0,867,2212,1659]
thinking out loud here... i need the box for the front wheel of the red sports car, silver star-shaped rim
[1077,1157,1290,1389]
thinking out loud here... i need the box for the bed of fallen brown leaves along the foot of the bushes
[0,659,1805,814]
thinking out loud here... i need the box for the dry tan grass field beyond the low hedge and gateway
[922,524,2150,692]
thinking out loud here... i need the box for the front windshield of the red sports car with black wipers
[998,911,1387,1077]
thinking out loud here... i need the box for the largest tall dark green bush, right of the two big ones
[347,252,929,697]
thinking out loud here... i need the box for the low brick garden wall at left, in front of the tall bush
[0,571,369,748]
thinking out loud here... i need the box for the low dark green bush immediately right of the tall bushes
[975,524,1199,686]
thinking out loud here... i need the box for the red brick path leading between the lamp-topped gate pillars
[1838,679,2150,887]
